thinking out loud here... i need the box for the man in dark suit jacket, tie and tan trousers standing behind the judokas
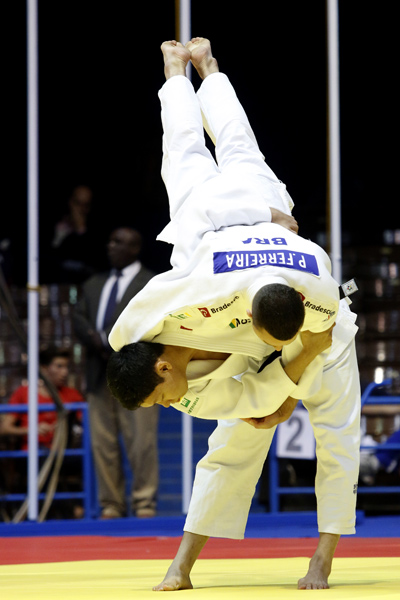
[74,227,158,518]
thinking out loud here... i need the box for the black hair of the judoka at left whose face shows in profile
[107,342,164,410]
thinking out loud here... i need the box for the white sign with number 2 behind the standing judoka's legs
[276,408,315,459]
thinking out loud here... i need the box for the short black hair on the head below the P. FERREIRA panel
[252,283,305,342]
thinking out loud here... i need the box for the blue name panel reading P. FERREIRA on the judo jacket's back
[214,250,319,277]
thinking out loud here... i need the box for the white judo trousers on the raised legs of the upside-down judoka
[157,73,293,251]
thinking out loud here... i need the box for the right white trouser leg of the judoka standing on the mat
[303,340,361,534]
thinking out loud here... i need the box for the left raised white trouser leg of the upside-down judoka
[159,75,219,219]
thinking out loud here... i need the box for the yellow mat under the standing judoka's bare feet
[0,558,400,600]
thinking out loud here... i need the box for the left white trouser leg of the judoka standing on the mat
[184,419,275,539]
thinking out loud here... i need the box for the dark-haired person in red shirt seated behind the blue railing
[1,348,84,450]
